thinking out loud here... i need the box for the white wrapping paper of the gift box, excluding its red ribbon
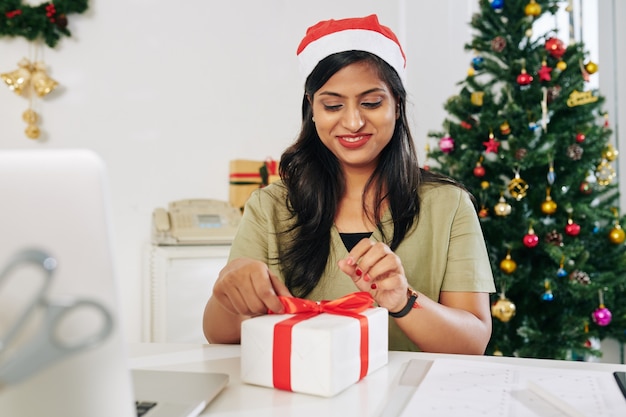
[241,307,389,397]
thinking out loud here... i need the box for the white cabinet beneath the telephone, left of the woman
[142,245,230,343]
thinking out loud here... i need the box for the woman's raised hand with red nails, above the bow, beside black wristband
[338,239,408,312]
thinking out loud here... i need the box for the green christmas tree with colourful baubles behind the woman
[426,0,626,359]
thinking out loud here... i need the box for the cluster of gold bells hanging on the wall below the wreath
[0,58,59,139]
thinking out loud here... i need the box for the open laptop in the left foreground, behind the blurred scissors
[0,149,228,417]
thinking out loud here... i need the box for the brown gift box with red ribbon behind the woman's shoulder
[228,158,280,209]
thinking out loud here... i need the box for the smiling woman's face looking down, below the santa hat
[312,62,398,170]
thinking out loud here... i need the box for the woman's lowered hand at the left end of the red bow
[207,258,291,316]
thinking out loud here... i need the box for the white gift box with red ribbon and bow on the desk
[241,292,389,397]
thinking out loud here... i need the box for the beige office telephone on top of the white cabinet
[152,199,241,245]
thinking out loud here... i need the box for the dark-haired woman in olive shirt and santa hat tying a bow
[203,15,495,354]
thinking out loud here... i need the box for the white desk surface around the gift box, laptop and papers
[129,343,626,417]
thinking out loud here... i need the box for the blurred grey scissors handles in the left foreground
[0,249,113,388]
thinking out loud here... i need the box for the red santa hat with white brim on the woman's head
[297,14,406,80]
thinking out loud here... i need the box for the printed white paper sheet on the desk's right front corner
[400,359,626,417]
